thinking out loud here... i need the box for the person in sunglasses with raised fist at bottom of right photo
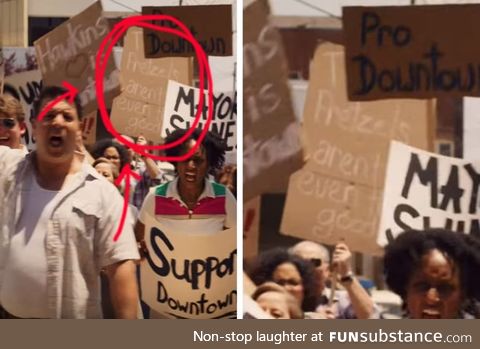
[290,241,380,319]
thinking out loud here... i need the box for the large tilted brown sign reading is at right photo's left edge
[243,0,303,201]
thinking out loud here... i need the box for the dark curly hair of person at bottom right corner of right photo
[384,229,480,315]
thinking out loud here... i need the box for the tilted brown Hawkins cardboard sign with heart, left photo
[34,1,120,113]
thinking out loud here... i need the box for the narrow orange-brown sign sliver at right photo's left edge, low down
[243,196,261,258]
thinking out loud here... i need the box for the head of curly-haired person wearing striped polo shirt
[165,129,226,189]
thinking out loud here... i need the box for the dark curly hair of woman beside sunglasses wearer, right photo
[249,248,319,311]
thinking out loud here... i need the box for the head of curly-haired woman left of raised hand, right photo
[250,248,318,311]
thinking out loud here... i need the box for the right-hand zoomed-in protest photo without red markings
[243,0,480,319]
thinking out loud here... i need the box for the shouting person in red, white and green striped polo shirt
[135,129,236,318]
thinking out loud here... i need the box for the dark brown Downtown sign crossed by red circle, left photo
[142,5,232,58]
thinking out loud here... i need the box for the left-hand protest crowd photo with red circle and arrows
[0,1,237,319]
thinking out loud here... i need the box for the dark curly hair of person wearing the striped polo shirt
[165,128,227,175]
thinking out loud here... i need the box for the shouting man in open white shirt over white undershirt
[0,87,139,319]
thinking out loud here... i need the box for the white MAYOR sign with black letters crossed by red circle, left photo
[162,81,237,162]
